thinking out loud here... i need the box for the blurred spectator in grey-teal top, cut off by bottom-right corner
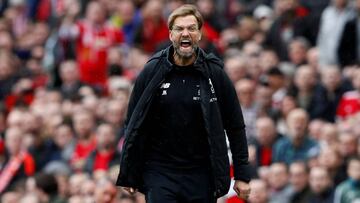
[334,157,360,203]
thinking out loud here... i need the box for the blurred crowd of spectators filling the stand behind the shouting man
[0,0,360,203]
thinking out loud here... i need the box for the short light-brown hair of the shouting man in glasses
[168,4,204,30]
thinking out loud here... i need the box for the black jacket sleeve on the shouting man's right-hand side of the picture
[217,70,250,182]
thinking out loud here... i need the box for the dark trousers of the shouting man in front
[144,168,216,203]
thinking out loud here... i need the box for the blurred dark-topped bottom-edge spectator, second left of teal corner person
[289,161,310,203]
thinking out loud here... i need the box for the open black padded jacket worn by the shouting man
[117,46,250,197]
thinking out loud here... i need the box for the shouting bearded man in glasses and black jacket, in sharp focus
[117,5,250,203]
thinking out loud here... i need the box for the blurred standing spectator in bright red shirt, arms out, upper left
[59,1,123,88]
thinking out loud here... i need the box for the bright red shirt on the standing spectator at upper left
[76,21,124,86]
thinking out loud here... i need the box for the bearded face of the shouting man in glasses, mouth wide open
[170,15,201,58]
